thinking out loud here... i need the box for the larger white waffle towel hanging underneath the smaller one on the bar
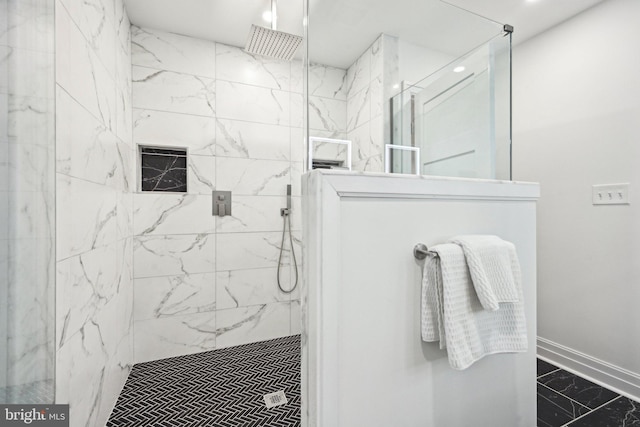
[421,244,527,370]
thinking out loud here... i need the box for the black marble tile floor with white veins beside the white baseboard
[537,359,640,427]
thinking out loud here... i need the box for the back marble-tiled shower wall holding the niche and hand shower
[132,27,330,362]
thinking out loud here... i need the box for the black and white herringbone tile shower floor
[107,335,301,427]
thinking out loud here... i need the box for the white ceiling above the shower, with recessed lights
[125,0,602,68]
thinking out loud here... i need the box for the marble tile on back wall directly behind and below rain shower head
[216,43,291,91]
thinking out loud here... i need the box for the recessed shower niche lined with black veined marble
[139,145,187,193]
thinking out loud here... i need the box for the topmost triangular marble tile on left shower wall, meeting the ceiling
[56,0,118,77]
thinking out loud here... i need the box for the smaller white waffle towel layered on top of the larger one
[450,235,520,311]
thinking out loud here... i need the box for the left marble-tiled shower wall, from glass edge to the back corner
[55,0,135,426]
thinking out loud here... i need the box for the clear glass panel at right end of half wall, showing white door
[392,33,511,180]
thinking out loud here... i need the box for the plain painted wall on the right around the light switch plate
[513,0,640,392]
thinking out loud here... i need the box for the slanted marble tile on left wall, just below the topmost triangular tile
[56,4,116,128]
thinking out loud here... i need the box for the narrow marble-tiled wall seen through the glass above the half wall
[346,34,388,172]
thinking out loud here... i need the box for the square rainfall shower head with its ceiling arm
[244,0,302,61]
